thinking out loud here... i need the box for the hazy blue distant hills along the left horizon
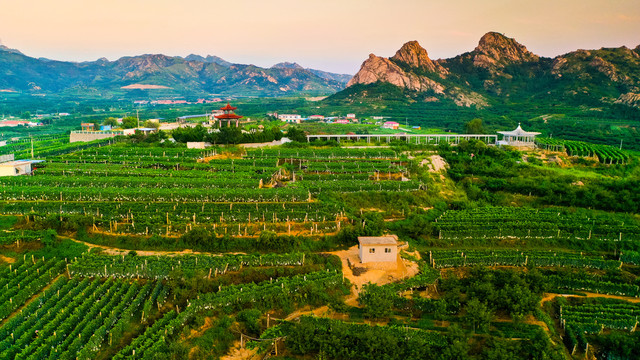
[0,46,349,97]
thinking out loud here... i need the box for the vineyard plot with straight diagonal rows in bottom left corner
[0,278,162,359]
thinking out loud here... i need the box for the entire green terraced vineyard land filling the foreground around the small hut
[0,128,640,360]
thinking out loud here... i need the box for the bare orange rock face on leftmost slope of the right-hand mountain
[347,54,444,94]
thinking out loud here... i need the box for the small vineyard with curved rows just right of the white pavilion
[536,138,629,164]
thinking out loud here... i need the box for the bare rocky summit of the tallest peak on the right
[473,32,539,69]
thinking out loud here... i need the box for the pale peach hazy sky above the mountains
[0,0,640,74]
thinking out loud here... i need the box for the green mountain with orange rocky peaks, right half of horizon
[340,32,640,108]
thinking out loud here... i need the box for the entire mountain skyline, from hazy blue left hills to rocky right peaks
[0,32,640,109]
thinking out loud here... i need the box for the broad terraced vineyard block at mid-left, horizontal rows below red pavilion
[0,143,426,236]
